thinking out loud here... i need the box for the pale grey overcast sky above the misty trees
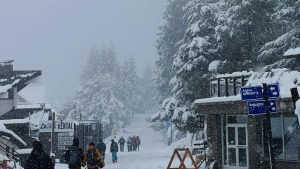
[0,0,167,107]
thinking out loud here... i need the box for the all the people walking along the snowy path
[25,135,141,169]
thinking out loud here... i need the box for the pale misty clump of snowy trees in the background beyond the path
[61,46,154,134]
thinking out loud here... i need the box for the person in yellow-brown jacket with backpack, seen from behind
[83,142,105,169]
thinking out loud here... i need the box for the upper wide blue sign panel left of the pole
[241,86,263,100]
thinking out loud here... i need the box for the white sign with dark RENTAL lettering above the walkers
[39,120,75,132]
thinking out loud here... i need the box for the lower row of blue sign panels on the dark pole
[248,100,276,115]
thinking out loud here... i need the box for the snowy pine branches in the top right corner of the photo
[257,0,300,71]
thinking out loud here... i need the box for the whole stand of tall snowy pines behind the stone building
[152,0,300,143]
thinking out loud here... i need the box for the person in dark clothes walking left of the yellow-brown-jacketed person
[65,138,83,169]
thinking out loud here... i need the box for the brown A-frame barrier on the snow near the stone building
[167,148,197,169]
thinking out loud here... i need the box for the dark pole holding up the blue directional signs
[263,83,276,169]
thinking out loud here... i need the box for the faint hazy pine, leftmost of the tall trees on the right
[155,0,188,103]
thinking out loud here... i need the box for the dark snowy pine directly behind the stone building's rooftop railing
[215,0,277,73]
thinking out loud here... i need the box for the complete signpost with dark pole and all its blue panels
[240,83,280,169]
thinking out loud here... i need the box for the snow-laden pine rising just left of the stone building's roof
[172,0,219,132]
